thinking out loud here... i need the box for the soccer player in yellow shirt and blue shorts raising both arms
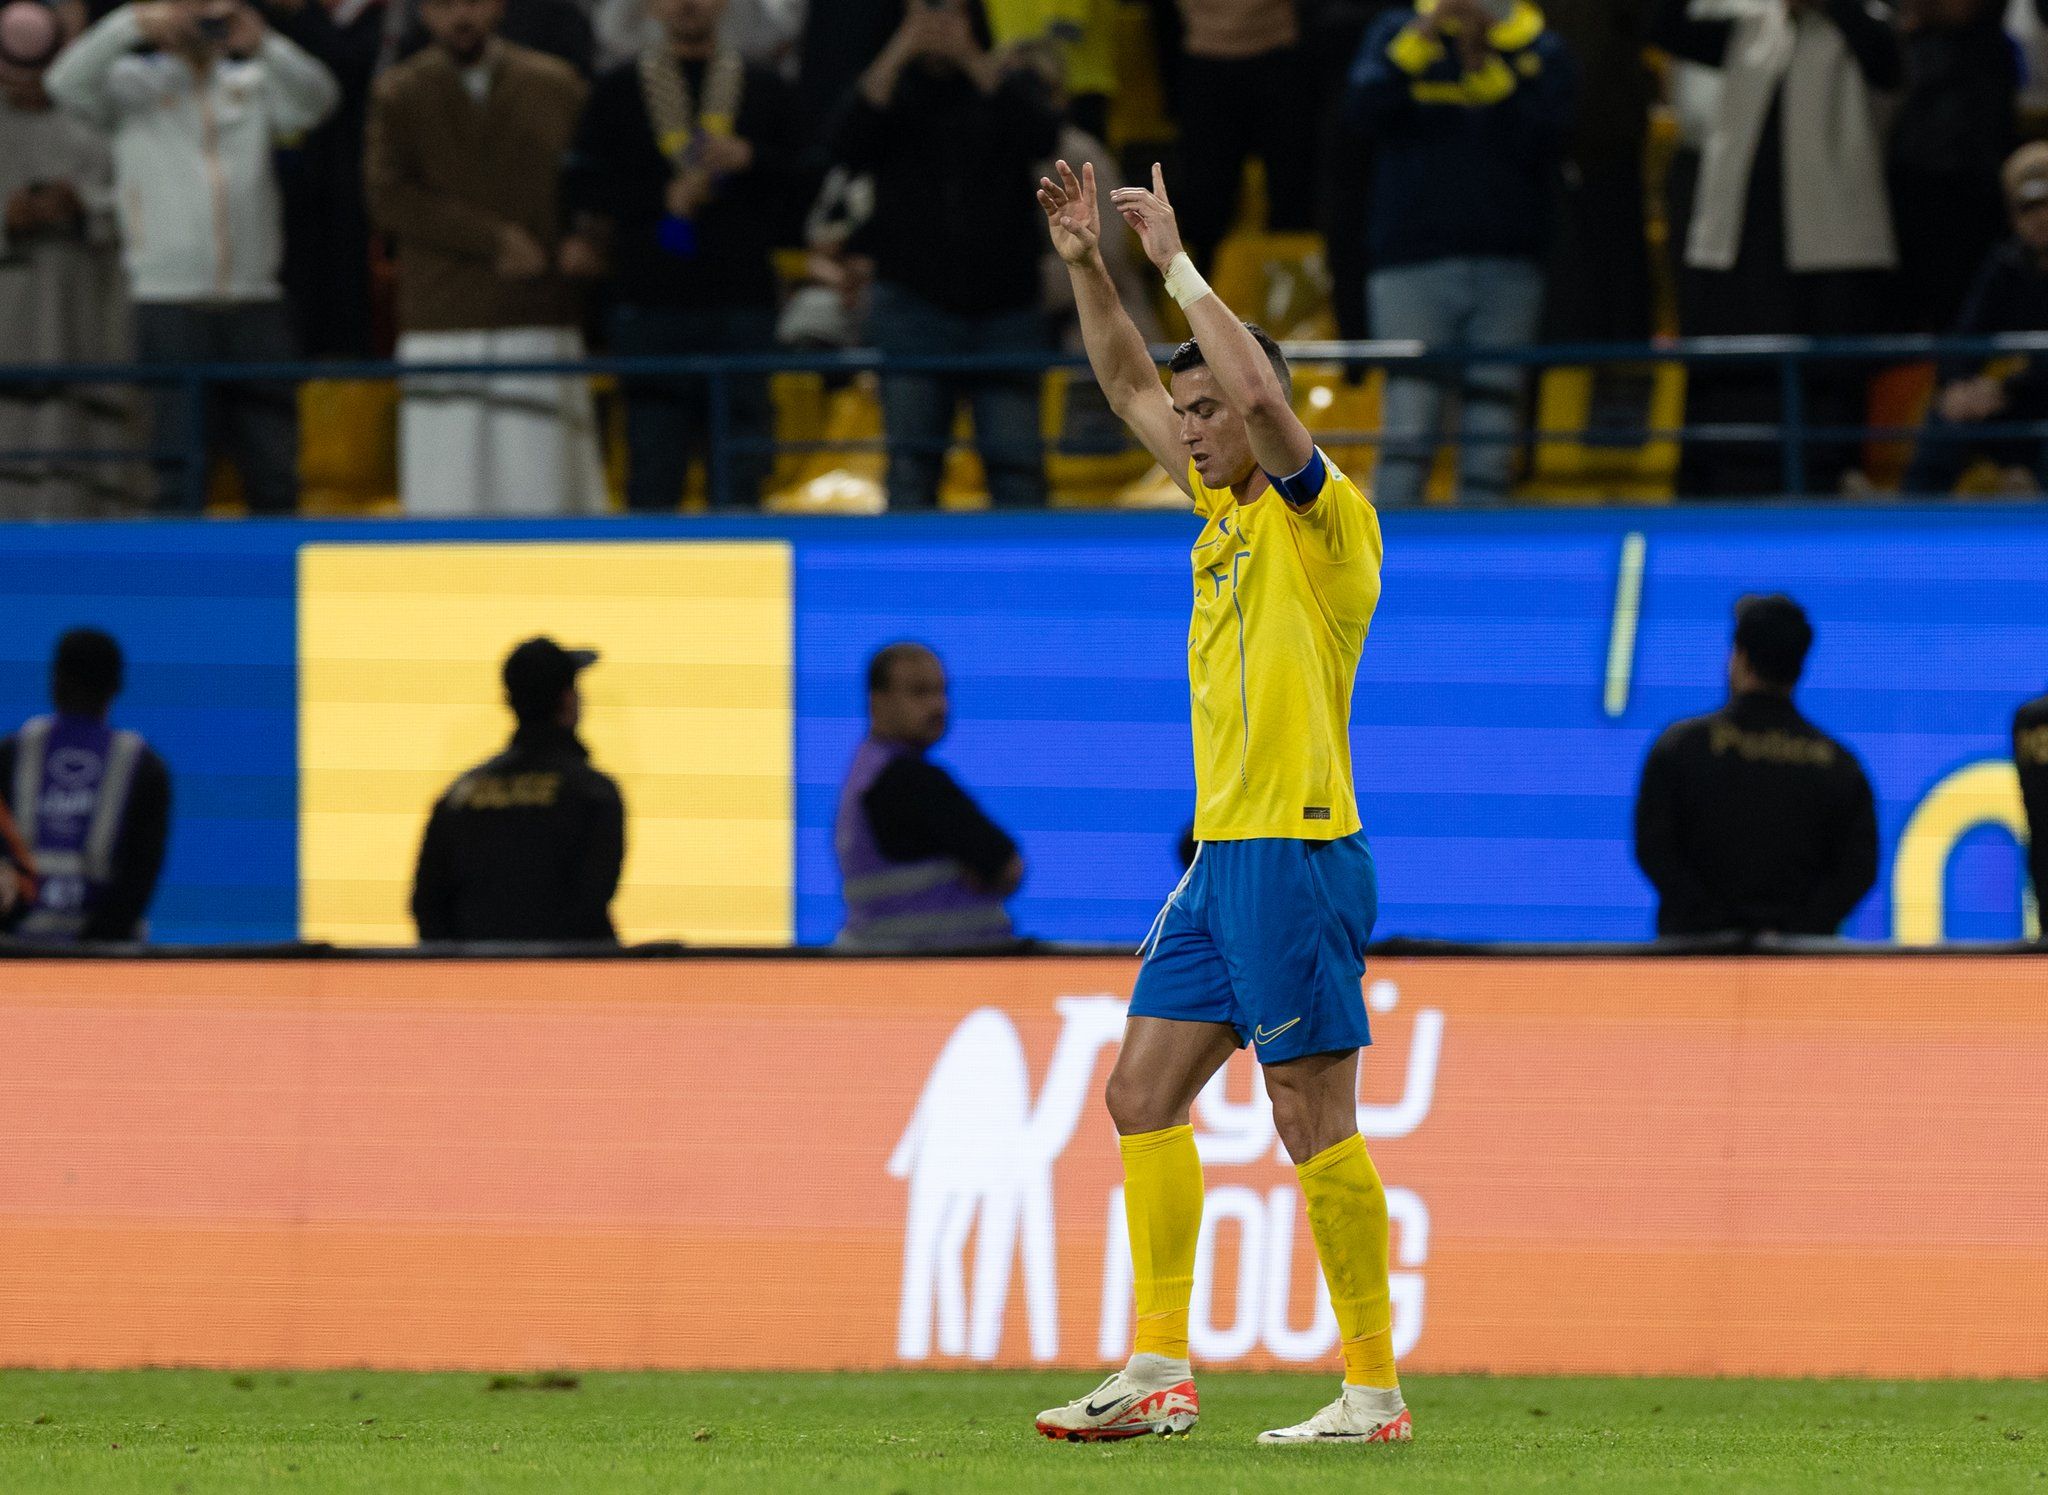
[1038,162,1411,1444]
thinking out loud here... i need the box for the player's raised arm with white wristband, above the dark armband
[1110,162,1315,483]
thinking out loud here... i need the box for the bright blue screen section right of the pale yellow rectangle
[797,508,2048,942]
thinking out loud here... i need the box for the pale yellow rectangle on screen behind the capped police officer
[299,541,797,944]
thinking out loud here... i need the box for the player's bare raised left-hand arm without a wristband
[1038,162,1192,498]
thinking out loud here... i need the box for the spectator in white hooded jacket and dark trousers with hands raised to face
[43,0,340,514]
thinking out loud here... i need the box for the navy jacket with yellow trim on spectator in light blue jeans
[1346,4,1575,266]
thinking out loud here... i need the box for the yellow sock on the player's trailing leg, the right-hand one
[1294,1133,1401,1386]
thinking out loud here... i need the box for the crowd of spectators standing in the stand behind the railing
[0,0,2048,514]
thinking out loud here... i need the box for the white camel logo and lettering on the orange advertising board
[889,979,1444,1362]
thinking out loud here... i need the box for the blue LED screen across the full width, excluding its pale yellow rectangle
[0,506,2048,944]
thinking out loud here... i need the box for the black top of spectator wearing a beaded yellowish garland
[561,61,807,311]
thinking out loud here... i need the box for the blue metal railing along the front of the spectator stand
[12,332,2048,512]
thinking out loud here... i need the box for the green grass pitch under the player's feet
[0,1370,2048,1495]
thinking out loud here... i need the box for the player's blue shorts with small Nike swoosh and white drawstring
[1130,831,1380,1065]
